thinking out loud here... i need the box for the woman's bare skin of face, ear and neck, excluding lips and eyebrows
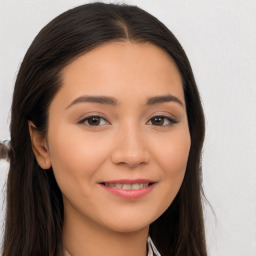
[30,41,190,256]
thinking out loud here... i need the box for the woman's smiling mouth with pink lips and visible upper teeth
[100,179,156,199]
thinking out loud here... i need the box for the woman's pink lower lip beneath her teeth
[99,183,156,199]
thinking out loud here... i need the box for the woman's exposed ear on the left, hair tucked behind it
[28,121,52,169]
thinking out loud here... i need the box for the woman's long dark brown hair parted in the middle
[3,3,207,256]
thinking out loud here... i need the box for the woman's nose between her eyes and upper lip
[111,125,150,168]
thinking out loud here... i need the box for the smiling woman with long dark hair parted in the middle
[2,3,206,256]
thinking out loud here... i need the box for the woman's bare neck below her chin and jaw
[63,205,149,256]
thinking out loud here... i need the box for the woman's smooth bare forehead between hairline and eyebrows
[56,41,184,105]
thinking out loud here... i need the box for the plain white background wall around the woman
[0,0,256,256]
